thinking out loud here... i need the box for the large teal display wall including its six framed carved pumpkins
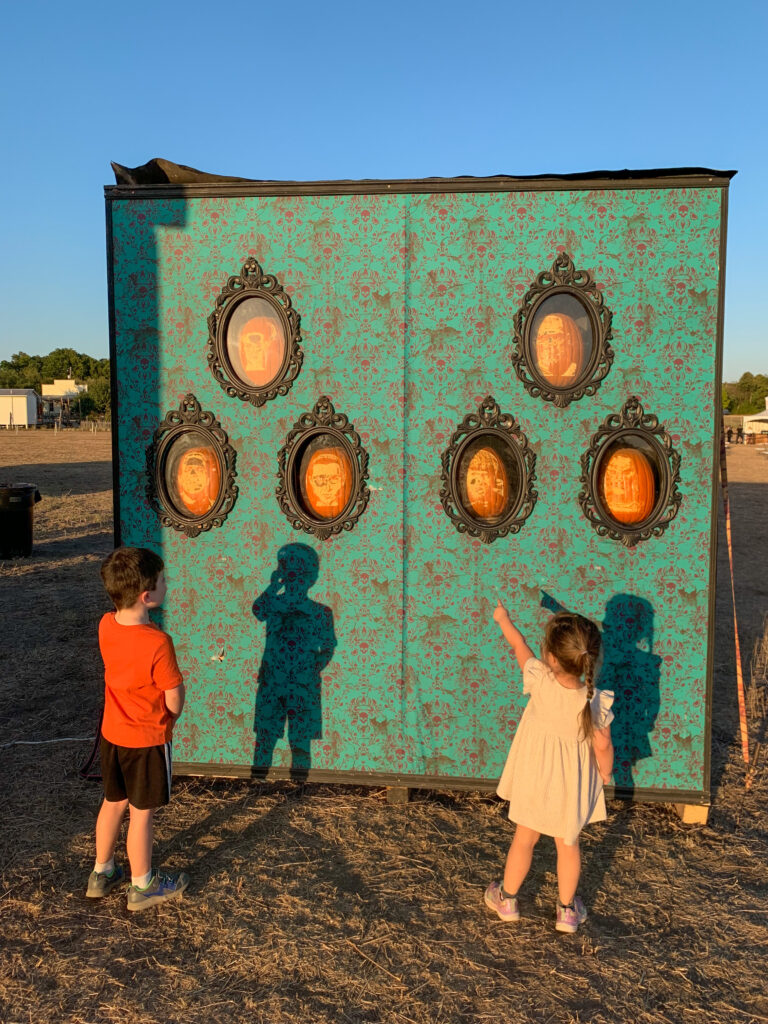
[106,170,730,802]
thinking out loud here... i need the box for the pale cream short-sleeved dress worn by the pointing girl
[496,657,613,846]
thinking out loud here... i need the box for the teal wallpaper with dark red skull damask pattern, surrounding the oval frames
[110,180,724,798]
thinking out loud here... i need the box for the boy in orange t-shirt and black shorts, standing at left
[86,548,189,910]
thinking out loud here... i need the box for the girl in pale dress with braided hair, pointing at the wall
[485,601,613,932]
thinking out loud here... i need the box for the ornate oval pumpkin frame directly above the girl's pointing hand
[440,395,539,544]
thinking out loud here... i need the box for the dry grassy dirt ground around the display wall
[0,431,768,1024]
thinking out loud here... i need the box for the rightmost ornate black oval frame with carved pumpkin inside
[579,395,682,548]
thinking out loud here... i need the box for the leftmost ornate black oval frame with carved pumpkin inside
[146,394,238,537]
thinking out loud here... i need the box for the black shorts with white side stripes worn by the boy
[101,736,171,811]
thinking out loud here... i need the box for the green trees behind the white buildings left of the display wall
[0,348,110,417]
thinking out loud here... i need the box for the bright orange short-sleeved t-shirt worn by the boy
[98,611,183,746]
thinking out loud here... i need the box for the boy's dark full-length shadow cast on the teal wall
[253,544,336,779]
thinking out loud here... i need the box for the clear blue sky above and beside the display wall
[0,0,768,380]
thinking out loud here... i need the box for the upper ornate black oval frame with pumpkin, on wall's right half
[512,253,613,409]
